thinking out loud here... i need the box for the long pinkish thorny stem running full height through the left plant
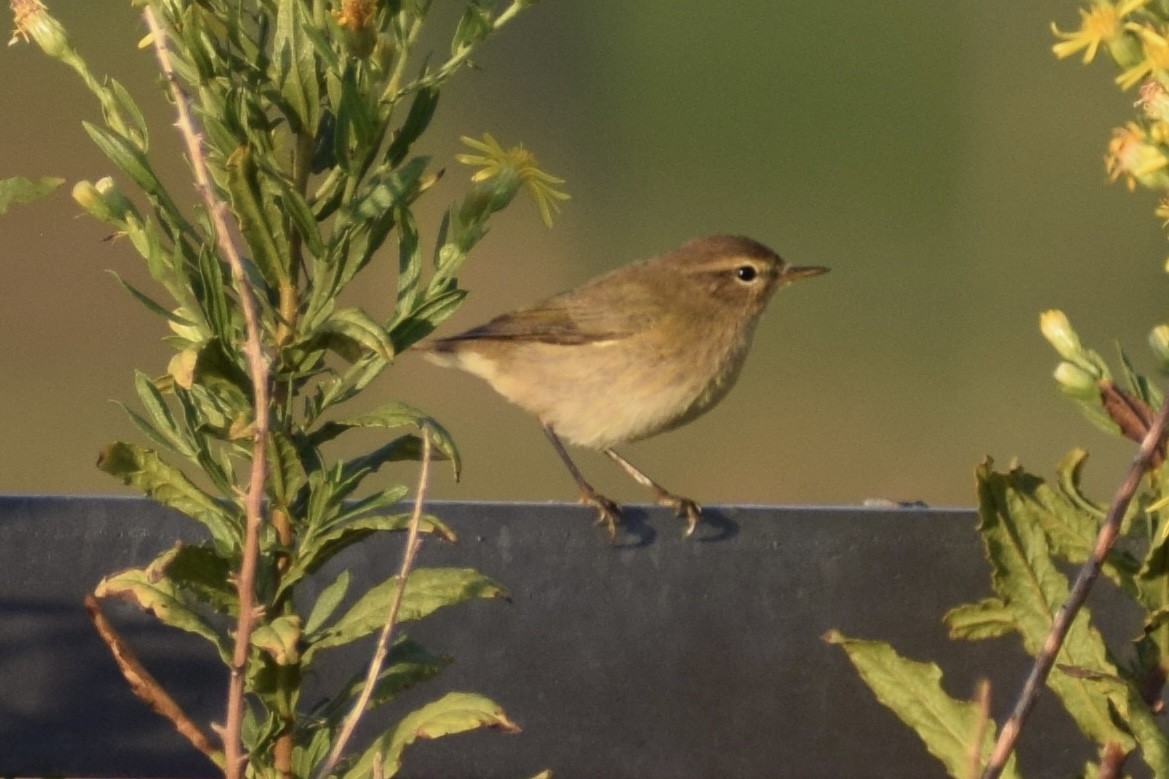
[143,6,269,779]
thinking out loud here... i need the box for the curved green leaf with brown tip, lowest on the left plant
[343,692,519,779]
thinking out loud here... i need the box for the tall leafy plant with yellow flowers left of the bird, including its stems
[0,0,567,779]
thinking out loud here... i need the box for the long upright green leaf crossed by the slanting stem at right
[977,462,1133,751]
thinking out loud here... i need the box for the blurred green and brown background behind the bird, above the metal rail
[0,0,1169,505]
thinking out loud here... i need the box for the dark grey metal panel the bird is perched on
[0,497,1092,779]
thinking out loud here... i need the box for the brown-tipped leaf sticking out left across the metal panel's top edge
[97,441,242,553]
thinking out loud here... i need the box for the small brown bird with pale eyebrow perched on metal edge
[423,235,828,538]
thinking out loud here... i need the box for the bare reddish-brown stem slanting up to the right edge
[982,398,1169,779]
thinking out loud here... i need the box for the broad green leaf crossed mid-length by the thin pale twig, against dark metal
[304,568,506,663]
